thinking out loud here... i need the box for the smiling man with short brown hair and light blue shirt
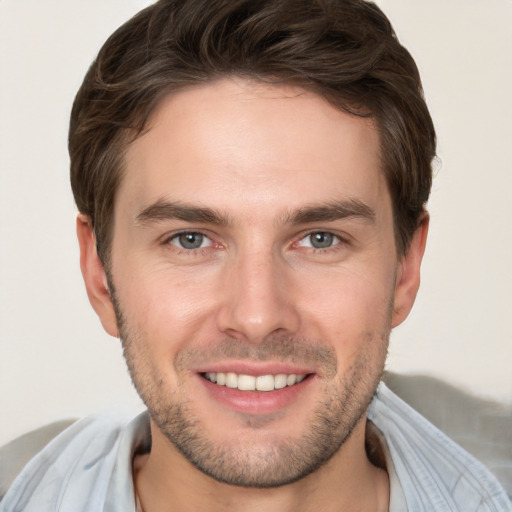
[1,0,510,512]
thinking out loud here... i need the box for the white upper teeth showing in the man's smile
[204,372,306,391]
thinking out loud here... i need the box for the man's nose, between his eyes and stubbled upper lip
[217,248,300,344]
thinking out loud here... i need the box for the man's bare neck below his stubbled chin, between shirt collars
[134,418,389,512]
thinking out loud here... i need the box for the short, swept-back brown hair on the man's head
[69,0,436,263]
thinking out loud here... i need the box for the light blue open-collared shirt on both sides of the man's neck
[0,383,512,512]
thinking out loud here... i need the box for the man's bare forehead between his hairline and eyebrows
[116,79,388,217]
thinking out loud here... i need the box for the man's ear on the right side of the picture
[391,213,430,327]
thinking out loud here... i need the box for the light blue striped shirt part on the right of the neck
[368,383,512,512]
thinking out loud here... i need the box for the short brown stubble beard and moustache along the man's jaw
[111,288,390,488]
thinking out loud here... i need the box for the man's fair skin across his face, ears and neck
[77,78,428,512]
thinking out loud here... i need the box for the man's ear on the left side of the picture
[76,213,119,338]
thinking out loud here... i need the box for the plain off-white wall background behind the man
[0,0,512,445]
